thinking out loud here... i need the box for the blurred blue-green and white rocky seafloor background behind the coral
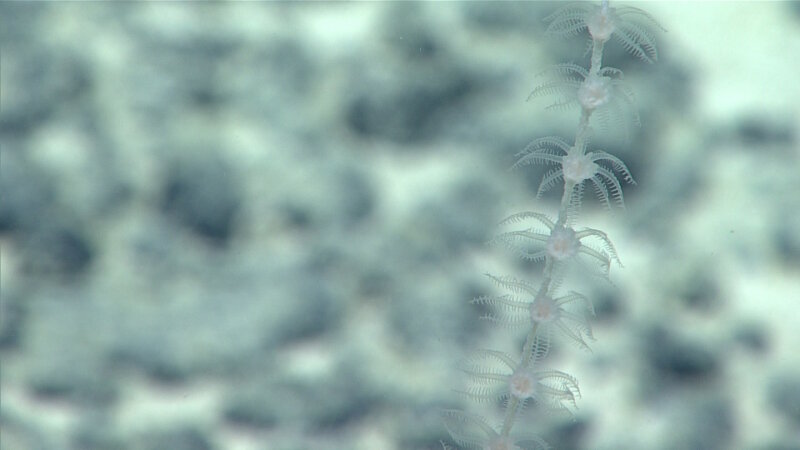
[0,2,800,450]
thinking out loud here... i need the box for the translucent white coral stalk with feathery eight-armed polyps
[445,1,657,449]
